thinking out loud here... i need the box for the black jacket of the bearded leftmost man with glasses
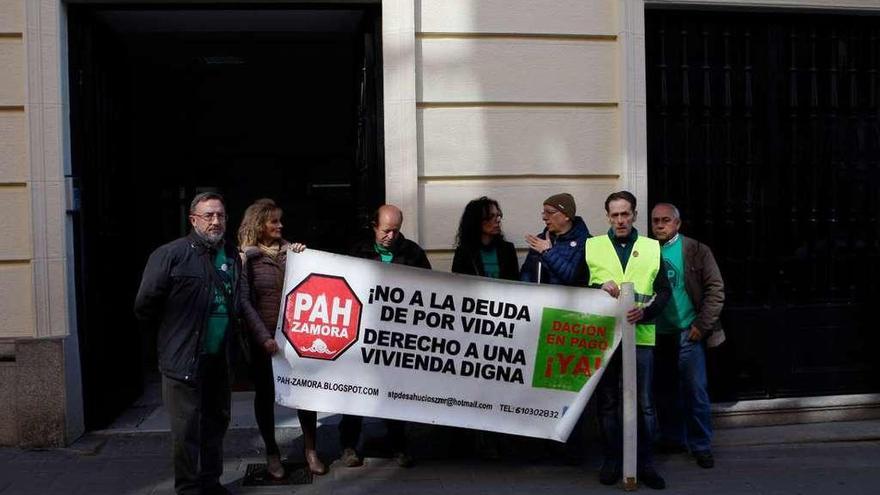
[134,233,241,381]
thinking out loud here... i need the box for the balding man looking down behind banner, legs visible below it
[339,205,431,467]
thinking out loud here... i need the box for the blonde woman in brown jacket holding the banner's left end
[238,199,327,478]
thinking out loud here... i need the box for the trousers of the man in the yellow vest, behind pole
[596,346,657,470]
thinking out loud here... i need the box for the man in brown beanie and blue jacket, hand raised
[520,193,590,285]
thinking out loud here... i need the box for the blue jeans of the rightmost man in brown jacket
[655,330,712,452]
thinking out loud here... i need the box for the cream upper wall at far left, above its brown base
[0,0,71,338]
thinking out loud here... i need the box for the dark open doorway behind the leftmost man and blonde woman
[68,2,384,428]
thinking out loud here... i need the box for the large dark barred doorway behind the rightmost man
[646,9,880,400]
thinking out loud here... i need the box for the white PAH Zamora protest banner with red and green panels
[273,249,632,441]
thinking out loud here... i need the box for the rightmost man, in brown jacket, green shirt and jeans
[651,203,724,468]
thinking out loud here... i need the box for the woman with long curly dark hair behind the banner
[452,196,519,280]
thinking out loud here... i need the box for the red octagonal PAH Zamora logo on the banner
[282,273,362,360]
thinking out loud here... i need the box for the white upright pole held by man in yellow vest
[618,282,638,492]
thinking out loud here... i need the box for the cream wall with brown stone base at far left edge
[0,0,83,446]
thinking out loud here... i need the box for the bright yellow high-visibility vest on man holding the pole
[585,235,660,346]
